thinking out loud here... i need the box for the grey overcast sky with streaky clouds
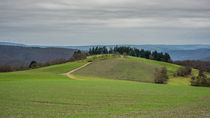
[0,0,210,46]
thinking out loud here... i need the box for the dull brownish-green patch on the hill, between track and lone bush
[73,58,159,82]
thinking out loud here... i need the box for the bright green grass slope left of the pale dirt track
[0,60,87,81]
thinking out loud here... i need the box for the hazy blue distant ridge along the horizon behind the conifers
[0,42,210,60]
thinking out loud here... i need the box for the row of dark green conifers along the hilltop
[89,46,171,62]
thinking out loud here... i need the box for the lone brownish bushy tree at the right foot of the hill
[154,67,168,84]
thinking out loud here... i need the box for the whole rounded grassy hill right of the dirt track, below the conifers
[73,56,188,82]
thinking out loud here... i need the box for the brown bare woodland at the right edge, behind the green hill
[173,60,210,73]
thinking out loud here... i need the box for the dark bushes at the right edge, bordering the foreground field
[191,70,210,87]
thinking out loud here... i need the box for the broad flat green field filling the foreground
[0,78,210,118]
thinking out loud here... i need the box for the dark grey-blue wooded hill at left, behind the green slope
[0,45,75,65]
